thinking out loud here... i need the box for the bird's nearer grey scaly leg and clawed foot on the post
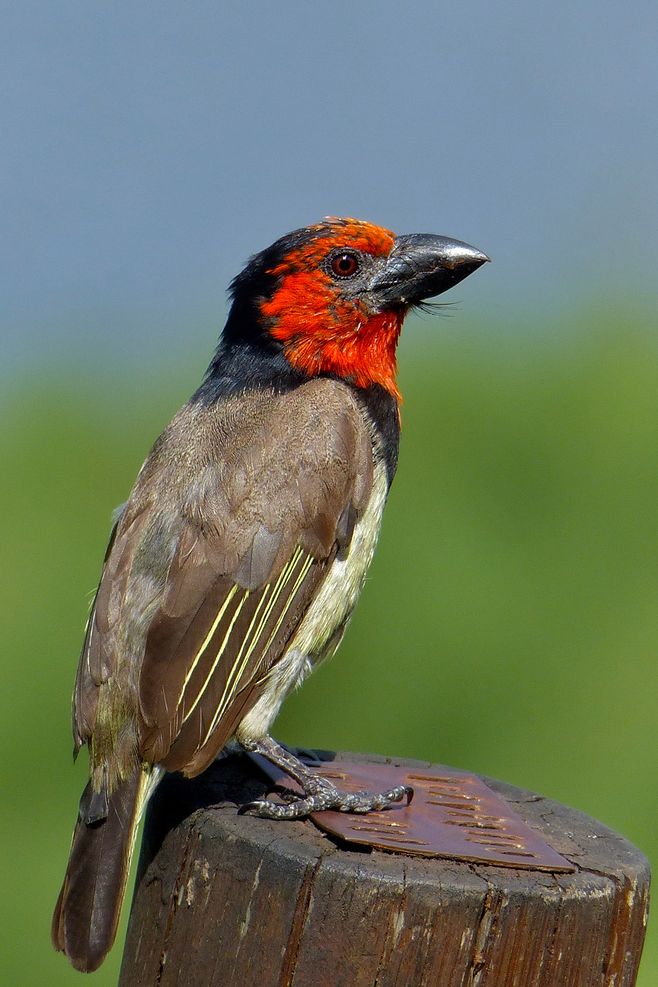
[238,737,413,819]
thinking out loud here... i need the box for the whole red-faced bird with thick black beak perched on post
[52,217,489,972]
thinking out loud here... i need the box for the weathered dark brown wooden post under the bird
[120,754,649,987]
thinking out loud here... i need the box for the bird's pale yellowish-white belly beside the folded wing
[236,464,388,740]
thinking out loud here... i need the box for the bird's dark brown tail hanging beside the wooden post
[52,768,150,973]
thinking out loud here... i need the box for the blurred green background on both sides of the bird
[0,308,658,987]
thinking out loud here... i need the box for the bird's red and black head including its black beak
[246,218,488,399]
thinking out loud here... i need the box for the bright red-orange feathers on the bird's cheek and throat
[261,224,406,401]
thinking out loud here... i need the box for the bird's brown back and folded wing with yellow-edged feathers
[76,380,373,788]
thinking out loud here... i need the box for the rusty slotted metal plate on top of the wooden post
[253,756,576,872]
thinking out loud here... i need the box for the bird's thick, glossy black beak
[369,233,489,309]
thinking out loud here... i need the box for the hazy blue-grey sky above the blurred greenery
[0,0,658,376]
